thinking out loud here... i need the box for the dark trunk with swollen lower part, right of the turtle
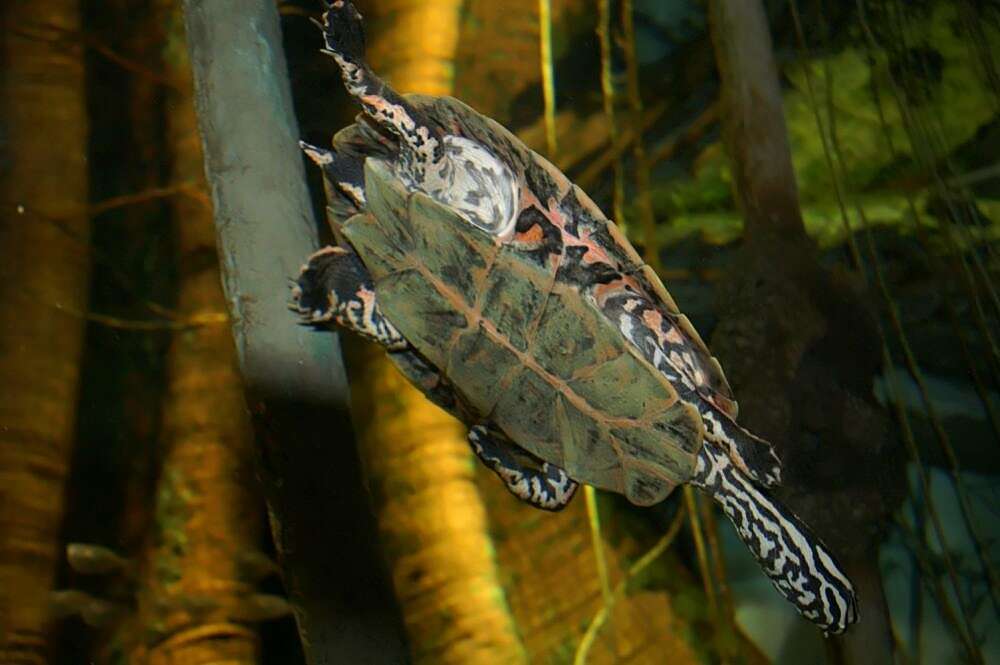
[710,0,903,662]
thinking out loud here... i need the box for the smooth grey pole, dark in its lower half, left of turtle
[184,0,405,665]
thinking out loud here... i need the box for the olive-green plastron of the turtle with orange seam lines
[341,158,704,505]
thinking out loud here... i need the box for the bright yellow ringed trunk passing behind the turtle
[351,0,524,665]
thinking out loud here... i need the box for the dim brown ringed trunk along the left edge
[0,0,89,664]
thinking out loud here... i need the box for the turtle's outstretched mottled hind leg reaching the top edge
[320,0,444,182]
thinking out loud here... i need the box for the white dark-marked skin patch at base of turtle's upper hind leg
[421,136,519,238]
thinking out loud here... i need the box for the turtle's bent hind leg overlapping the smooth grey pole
[292,247,409,351]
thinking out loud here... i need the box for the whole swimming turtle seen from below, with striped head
[291,0,858,634]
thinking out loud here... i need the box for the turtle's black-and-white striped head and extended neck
[691,441,858,634]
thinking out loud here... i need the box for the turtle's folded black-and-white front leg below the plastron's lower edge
[469,425,579,511]
